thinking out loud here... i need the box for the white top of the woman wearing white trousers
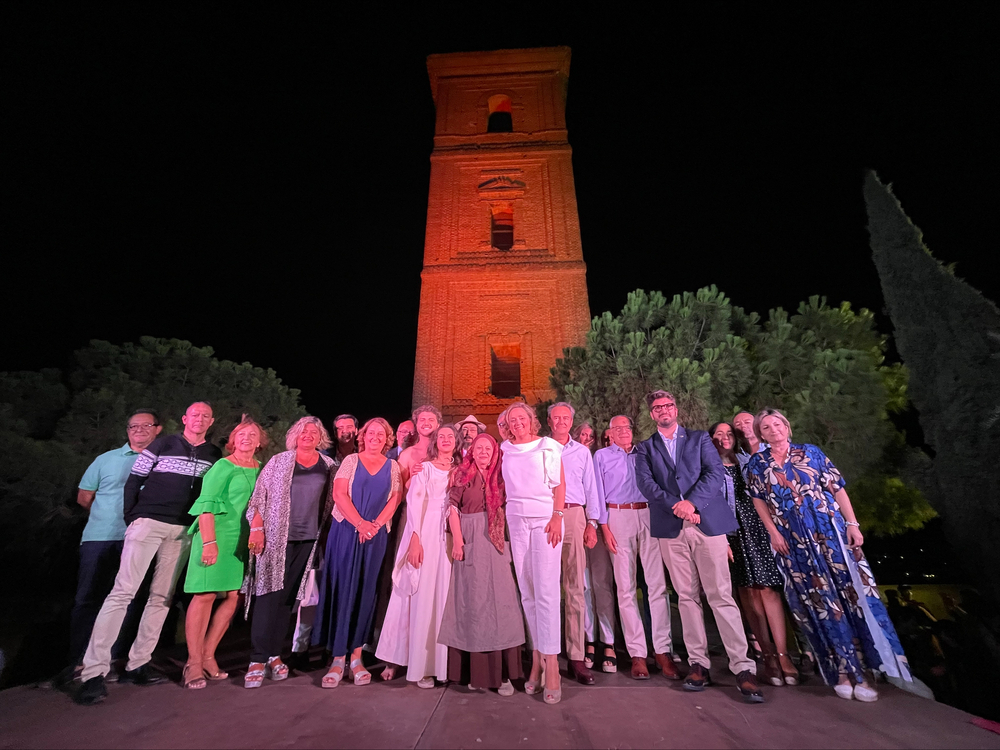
[500,437,563,518]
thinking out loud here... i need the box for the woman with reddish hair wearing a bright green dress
[183,415,267,690]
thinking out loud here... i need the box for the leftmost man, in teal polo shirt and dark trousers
[66,409,163,676]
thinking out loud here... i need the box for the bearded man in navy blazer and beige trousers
[635,391,764,703]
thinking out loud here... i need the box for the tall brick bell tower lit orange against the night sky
[413,47,590,434]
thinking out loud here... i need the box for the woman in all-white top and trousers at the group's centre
[497,403,566,703]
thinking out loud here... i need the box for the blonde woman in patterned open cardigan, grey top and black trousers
[243,417,333,688]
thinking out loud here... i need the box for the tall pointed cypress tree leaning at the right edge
[864,172,1000,603]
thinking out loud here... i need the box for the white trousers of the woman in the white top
[507,516,562,655]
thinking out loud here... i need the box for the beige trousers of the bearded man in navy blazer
[659,521,757,674]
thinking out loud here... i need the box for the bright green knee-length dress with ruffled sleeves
[184,459,260,594]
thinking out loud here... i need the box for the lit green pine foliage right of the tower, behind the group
[551,286,934,534]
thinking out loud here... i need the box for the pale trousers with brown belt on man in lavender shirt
[608,508,671,658]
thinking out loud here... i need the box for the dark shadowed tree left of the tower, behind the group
[0,337,305,598]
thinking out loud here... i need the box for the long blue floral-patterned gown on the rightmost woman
[747,444,911,685]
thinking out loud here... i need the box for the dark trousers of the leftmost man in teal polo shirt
[69,540,149,665]
